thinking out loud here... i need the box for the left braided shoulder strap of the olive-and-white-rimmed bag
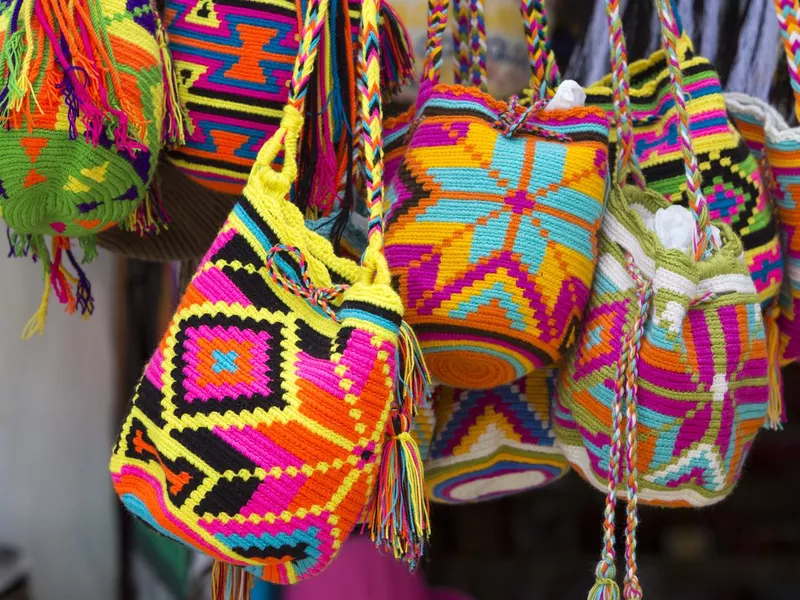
[606,0,645,189]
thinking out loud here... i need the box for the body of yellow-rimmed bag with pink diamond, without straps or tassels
[110,196,402,583]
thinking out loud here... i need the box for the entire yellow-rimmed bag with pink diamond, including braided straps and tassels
[110,0,428,598]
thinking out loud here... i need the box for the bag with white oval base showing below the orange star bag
[425,369,569,504]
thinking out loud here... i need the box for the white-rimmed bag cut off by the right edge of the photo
[725,93,800,367]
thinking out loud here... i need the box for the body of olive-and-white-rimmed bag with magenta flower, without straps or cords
[555,187,769,506]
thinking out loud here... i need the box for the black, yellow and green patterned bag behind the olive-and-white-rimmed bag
[586,36,783,308]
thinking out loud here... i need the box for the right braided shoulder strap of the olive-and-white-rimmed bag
[655,0,713,260]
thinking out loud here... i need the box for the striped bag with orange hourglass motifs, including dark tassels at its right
[165,0,413,204]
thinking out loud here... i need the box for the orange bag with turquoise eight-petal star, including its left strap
[386,0,608,389]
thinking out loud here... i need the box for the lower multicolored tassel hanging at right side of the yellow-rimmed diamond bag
[367,411,430,569]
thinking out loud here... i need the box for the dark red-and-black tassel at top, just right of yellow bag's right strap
[378,2,416,101]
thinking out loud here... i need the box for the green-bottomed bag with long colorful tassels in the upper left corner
[0,0,183,330]
